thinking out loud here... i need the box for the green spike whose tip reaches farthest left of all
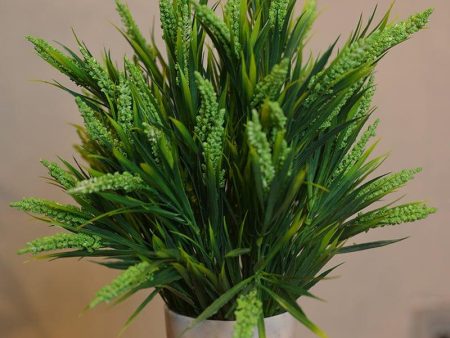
[11,197,88,226]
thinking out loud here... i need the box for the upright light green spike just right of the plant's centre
[247,110,275,191]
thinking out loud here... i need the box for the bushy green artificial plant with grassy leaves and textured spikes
[12,0,435,338]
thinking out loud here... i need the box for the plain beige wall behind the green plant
[0,0,450,338]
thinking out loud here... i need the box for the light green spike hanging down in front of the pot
[233,290,262,338]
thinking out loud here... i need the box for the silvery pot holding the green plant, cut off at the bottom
[165,307,295,338]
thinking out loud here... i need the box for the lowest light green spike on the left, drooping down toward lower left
[88,262,156,309]
